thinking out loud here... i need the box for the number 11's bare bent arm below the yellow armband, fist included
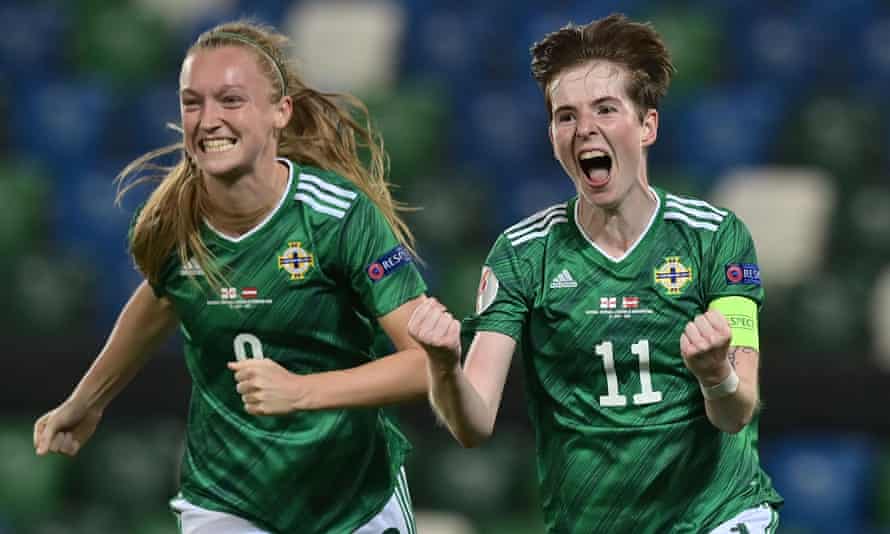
[680,310,760,434]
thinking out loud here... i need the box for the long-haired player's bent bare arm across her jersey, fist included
[229,297,427,415]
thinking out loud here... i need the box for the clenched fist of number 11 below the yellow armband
[680,310,732,386]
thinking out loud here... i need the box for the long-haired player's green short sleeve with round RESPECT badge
[338,195,426,317]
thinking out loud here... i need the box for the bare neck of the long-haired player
[204,157,289,237]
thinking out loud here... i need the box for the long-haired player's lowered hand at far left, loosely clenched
[34,399,102,456]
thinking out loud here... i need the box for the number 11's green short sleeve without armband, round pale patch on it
[462,235,531,342]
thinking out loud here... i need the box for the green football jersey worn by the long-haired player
[146,160,426,533]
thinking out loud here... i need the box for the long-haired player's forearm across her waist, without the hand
[300,348,427,410]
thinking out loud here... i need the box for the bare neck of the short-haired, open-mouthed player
[578,184,658,257]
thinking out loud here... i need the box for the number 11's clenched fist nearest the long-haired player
[408,297,460,369]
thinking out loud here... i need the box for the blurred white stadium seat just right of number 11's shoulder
[710,167,837,287]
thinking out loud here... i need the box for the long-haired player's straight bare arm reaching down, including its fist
[34,282,177,455]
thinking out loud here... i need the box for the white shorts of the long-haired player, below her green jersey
[170,468,417,534]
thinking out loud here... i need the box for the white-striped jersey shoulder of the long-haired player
[291,165,367,220]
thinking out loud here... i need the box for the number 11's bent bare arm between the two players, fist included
[409,299,516,447]
